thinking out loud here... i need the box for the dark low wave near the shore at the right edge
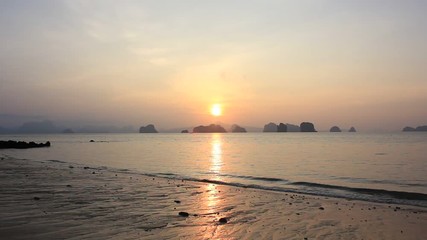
[291,182,427,201]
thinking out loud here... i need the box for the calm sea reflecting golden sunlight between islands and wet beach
[0,132,427,207]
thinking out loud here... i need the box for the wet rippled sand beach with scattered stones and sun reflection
[0,156,427,240]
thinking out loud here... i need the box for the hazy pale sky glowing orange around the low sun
[0,0,427,131]
